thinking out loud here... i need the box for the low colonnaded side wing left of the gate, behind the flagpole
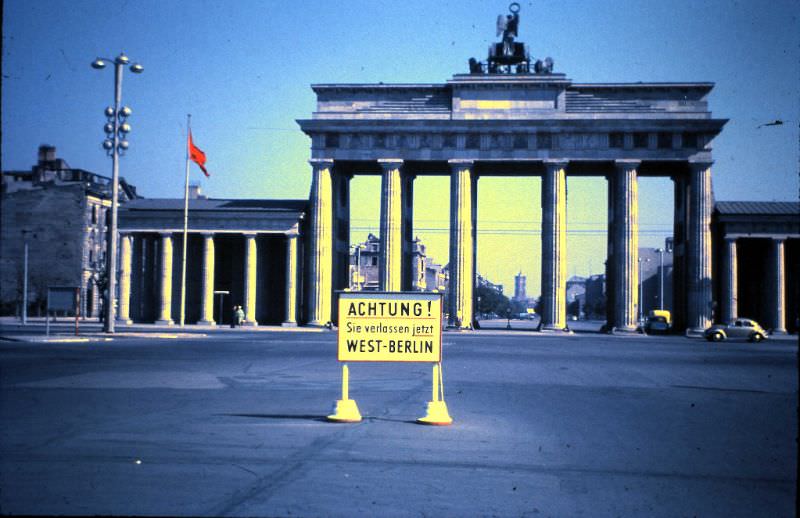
[119,199,307,326]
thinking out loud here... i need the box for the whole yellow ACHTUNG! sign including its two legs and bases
[328,291,453,426]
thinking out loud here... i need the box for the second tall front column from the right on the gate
[612,160,640,332]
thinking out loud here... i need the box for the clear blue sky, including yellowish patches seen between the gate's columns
[2,0,800,291]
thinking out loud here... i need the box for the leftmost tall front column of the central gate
[308,159,333,326]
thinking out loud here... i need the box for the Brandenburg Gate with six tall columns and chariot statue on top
[298,4,726,332]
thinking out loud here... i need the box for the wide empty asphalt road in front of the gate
[0,331,798,517]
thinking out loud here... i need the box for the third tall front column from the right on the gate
[539,160,567,331]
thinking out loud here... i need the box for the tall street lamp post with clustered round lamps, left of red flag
[92,52,144,333]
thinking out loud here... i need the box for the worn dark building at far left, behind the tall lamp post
[0,145,137,317]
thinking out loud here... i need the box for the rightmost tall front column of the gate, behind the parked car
[686,162,714,334]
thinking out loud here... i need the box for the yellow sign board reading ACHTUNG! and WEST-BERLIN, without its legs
[339,291,442,362]
